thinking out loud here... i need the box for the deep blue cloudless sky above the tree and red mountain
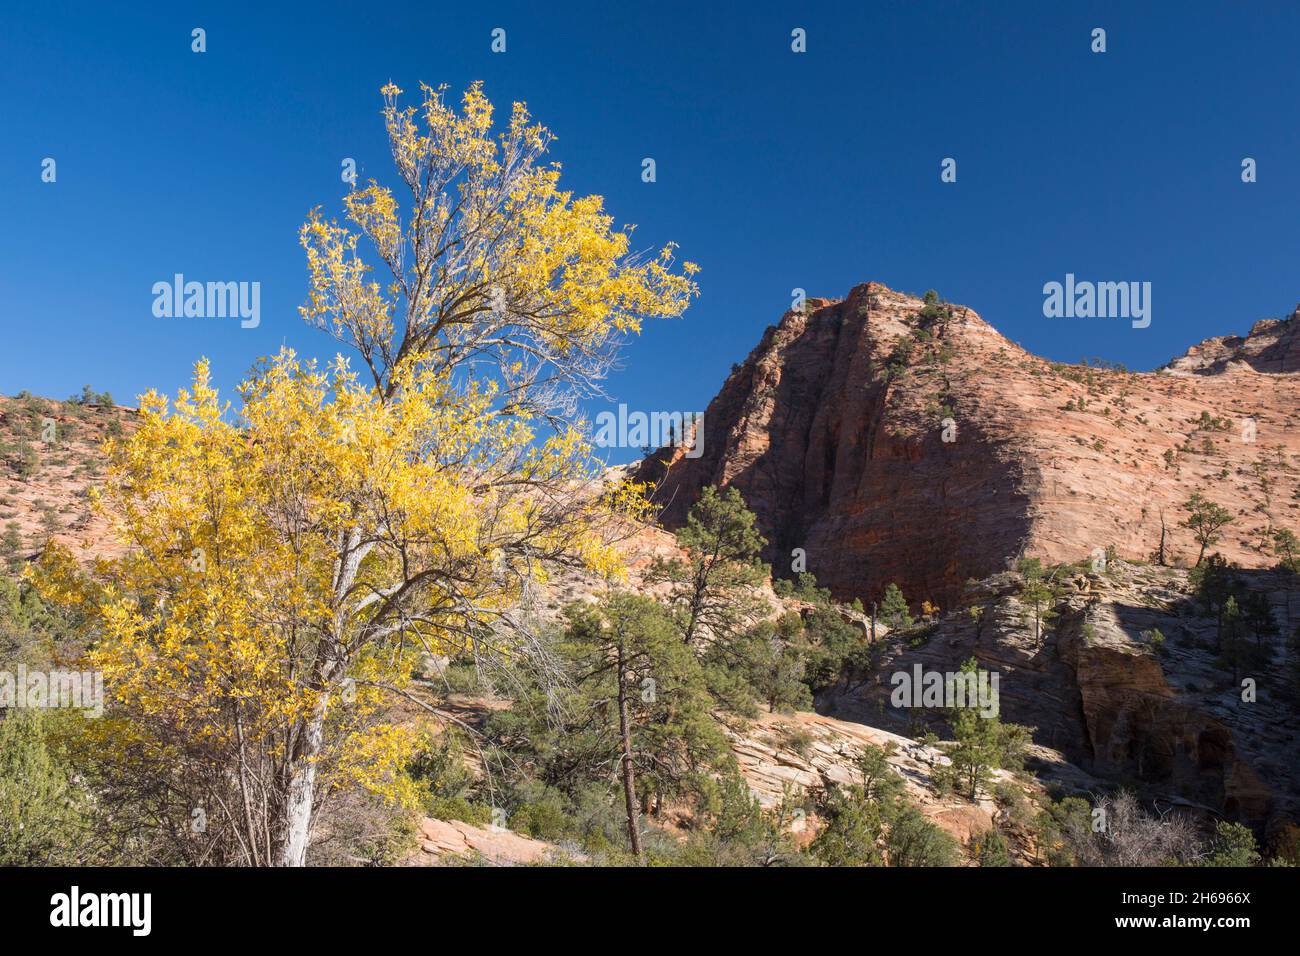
[0,0,1300,459]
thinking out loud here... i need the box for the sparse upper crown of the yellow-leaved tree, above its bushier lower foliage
[300,83,697,418]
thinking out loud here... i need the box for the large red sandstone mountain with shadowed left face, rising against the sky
[637,282,1300,606]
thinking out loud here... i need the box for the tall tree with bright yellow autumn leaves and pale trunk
[33,85,697,865]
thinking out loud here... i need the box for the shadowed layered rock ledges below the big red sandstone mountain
[818,562,1300,832]
